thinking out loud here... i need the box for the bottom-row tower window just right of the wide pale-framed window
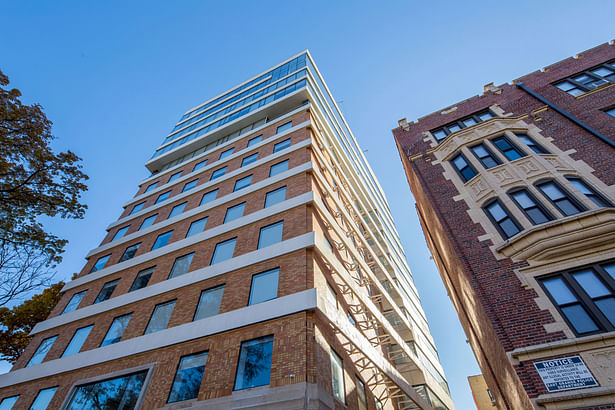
[168,352,207,403]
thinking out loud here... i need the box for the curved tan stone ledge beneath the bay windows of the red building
[496,208,615,263]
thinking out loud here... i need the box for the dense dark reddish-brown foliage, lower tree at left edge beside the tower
[0,282,64,363]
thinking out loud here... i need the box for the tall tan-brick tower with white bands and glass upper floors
[0,52,454,410]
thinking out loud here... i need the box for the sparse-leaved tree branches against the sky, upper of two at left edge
[0,71,88,306]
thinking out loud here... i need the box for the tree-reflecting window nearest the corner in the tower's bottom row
[234,336,273,390]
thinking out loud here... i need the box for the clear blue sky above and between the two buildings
[0,0,615,410]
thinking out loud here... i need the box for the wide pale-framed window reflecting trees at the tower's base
[66,370,147,410]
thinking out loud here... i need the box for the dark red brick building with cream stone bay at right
[393,41,615,409]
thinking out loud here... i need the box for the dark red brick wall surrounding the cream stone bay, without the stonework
[393,44,615,403]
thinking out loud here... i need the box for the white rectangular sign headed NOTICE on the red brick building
[534,356,598,392]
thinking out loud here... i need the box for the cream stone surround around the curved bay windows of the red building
[424,113,615,259]
